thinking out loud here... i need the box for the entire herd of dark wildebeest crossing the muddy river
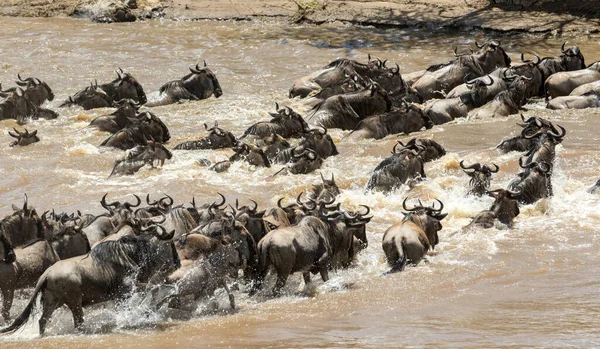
[0,40,600,335]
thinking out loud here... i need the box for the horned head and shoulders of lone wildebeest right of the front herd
[402,197,448,249]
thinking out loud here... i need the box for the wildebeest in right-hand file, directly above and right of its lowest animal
[508,158,552,205]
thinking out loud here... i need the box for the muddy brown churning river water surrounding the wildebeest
[0,18,600,348]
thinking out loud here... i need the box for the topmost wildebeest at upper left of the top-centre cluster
[289,55,386,98]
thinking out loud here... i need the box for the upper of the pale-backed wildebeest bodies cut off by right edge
[544,61,600,98]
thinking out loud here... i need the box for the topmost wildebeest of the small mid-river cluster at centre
[240,103,308,138]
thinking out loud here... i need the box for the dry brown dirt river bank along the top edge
[0,0,600,33]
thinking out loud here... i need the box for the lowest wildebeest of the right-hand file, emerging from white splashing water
[464,189,521,229]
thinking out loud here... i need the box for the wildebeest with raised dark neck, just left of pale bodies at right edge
[468,71,532,119]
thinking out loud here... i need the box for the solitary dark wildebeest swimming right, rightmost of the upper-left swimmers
[146,61,223,107]
